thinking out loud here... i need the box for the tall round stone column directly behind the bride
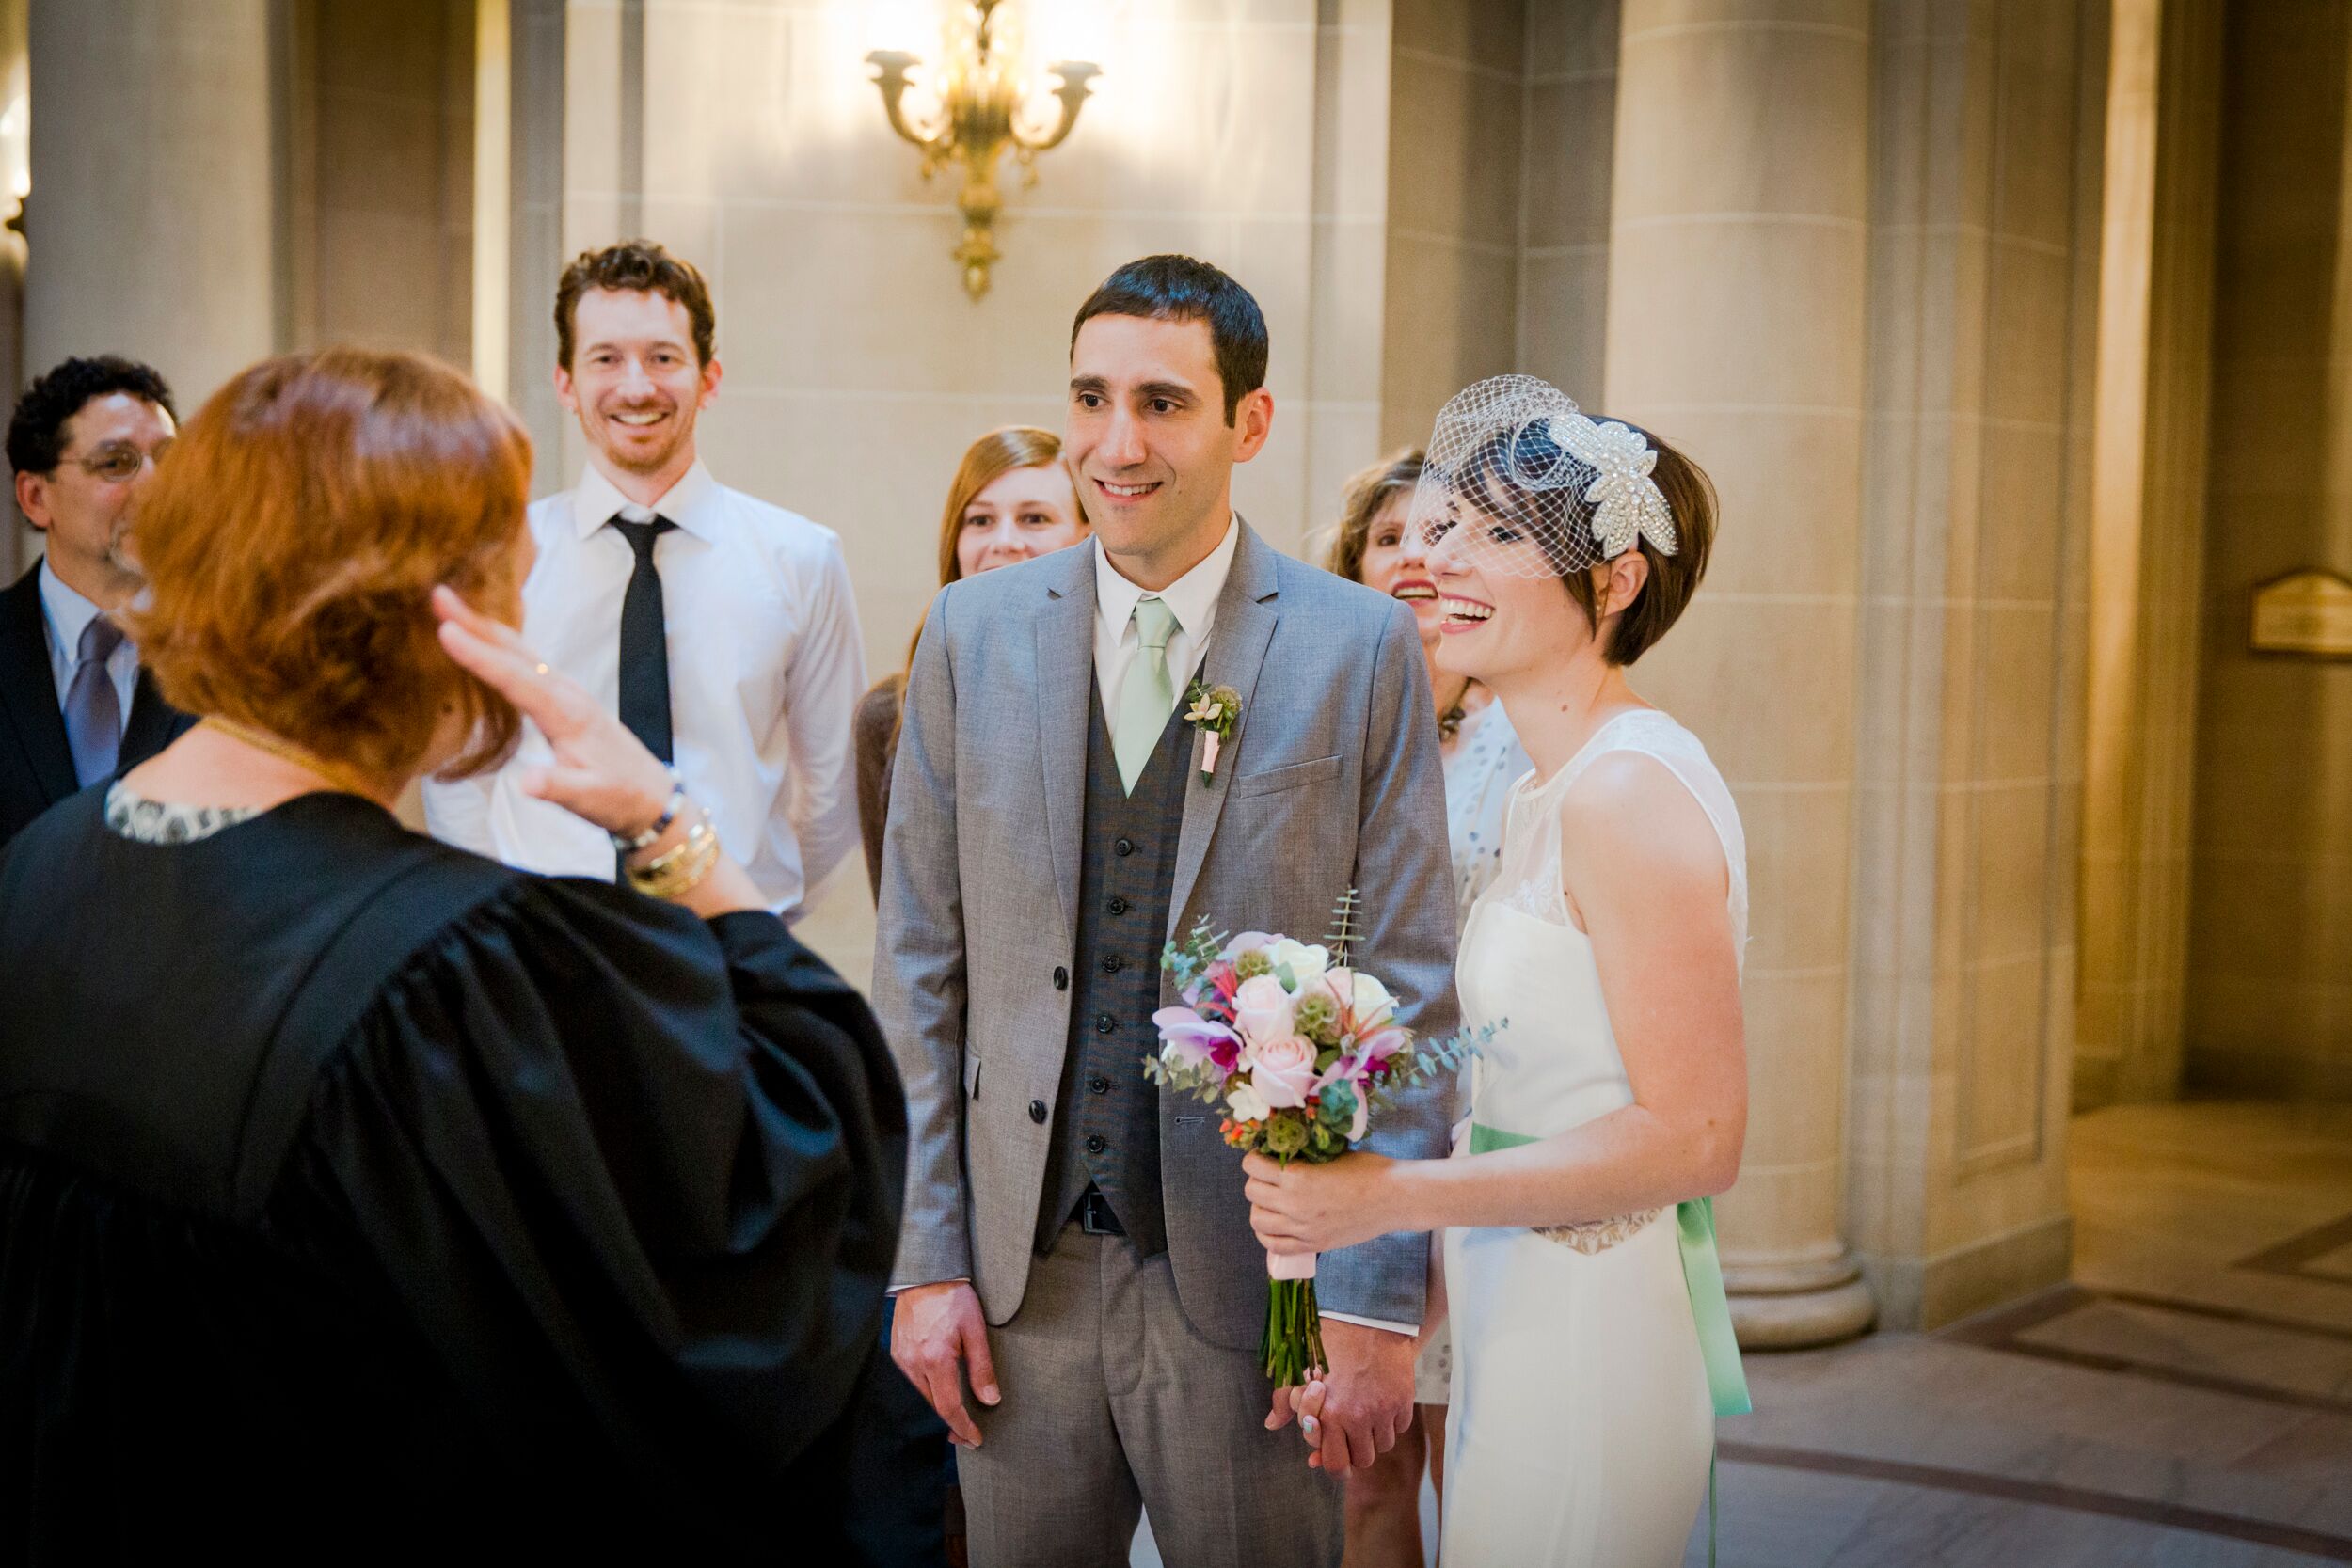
[1604,0,1875,1345]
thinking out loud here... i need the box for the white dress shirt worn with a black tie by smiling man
[423,463,866,919]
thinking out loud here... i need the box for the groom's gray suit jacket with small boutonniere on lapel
[875,524,1454,1347]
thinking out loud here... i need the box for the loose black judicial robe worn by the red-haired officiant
[0,787,906,1563]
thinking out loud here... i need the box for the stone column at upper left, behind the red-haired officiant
[26,0,282,404]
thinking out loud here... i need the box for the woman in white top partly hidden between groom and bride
[1325,447,1534,1568]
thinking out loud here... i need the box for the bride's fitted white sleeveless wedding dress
[1439,710,1748,1568]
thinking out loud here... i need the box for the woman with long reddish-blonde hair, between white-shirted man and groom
[851,425,1087,895]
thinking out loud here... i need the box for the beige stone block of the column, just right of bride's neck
[1635,597,1853,784]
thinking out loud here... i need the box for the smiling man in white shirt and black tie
[426,240,866,919]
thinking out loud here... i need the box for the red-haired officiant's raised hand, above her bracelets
[433,588,671,834]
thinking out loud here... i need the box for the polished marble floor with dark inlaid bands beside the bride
[1134,1102,2352,1568]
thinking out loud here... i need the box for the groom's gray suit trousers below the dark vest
[958,1225,1341,1568]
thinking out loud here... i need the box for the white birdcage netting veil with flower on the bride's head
[1406,376,1675,578]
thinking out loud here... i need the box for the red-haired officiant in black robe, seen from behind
[0,350,906,1563]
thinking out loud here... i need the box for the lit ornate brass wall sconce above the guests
[866,0,1104,298]
